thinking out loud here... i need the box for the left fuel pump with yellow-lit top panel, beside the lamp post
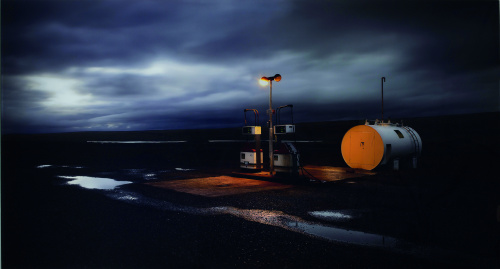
[240,109,263,172]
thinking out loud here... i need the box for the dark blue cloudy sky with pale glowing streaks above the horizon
[1,0,500,133]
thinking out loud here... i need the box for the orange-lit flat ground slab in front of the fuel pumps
[147,176,292,197]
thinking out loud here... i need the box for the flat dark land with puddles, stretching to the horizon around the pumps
[1,113,500,268]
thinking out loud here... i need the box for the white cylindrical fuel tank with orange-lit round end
[341,123,422,170]
